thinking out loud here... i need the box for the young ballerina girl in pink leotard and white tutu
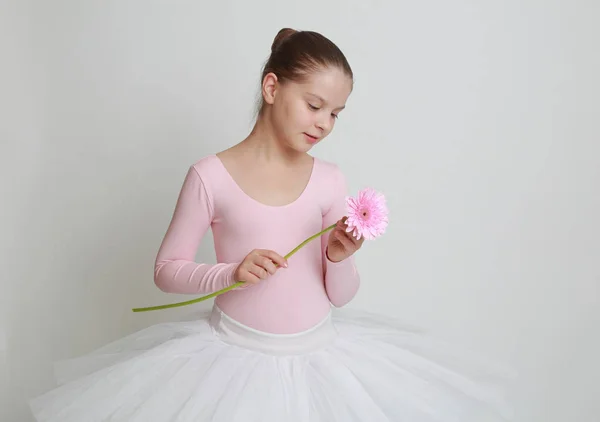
[31,29,507,422]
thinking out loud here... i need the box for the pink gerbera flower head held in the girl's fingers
[346,188,388,240]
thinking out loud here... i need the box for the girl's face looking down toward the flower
[265,68,352,152]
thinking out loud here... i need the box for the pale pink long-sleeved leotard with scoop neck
[154,155,360,334]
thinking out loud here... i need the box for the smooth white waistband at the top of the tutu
[209,304,337,355]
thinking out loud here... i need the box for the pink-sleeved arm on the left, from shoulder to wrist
[154,167,239,294]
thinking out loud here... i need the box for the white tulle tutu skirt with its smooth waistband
[30,306,510,422]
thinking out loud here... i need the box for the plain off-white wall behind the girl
[0,0,600,422]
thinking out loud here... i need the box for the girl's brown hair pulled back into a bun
[259,28,354,112]
